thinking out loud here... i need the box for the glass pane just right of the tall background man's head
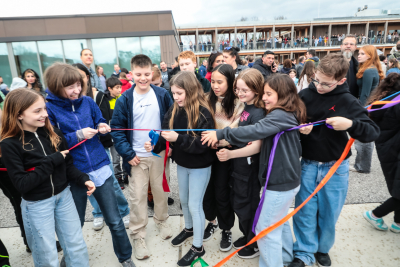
[92,38,117,77]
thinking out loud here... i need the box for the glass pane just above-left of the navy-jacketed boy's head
[117,37,141,70]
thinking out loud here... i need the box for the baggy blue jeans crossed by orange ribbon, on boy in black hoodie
[293,158,349,265]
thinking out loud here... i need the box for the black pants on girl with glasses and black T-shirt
[231,155,261,245]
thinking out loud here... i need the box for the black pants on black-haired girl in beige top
[203,159,235,230]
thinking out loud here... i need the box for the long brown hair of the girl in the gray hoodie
[264,73,307,123]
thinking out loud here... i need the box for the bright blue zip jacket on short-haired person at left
[46,90,110,173]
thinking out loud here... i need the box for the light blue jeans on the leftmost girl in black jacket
[21,186,89,267]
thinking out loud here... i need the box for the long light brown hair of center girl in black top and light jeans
[169,71,214,135]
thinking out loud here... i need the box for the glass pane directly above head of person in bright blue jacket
[38,41,64,73]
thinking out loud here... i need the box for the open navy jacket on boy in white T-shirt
[111,84,173,173]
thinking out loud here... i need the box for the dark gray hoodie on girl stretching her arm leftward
[217,109,301,191]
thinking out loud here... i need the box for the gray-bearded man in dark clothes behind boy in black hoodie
[340,34,359,98]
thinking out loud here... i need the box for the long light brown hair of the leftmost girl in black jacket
[0,88,61,151]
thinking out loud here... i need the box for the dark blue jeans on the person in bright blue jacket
[70,176,132,262]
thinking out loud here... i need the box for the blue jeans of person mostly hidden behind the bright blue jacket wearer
[89,148,130,218]
